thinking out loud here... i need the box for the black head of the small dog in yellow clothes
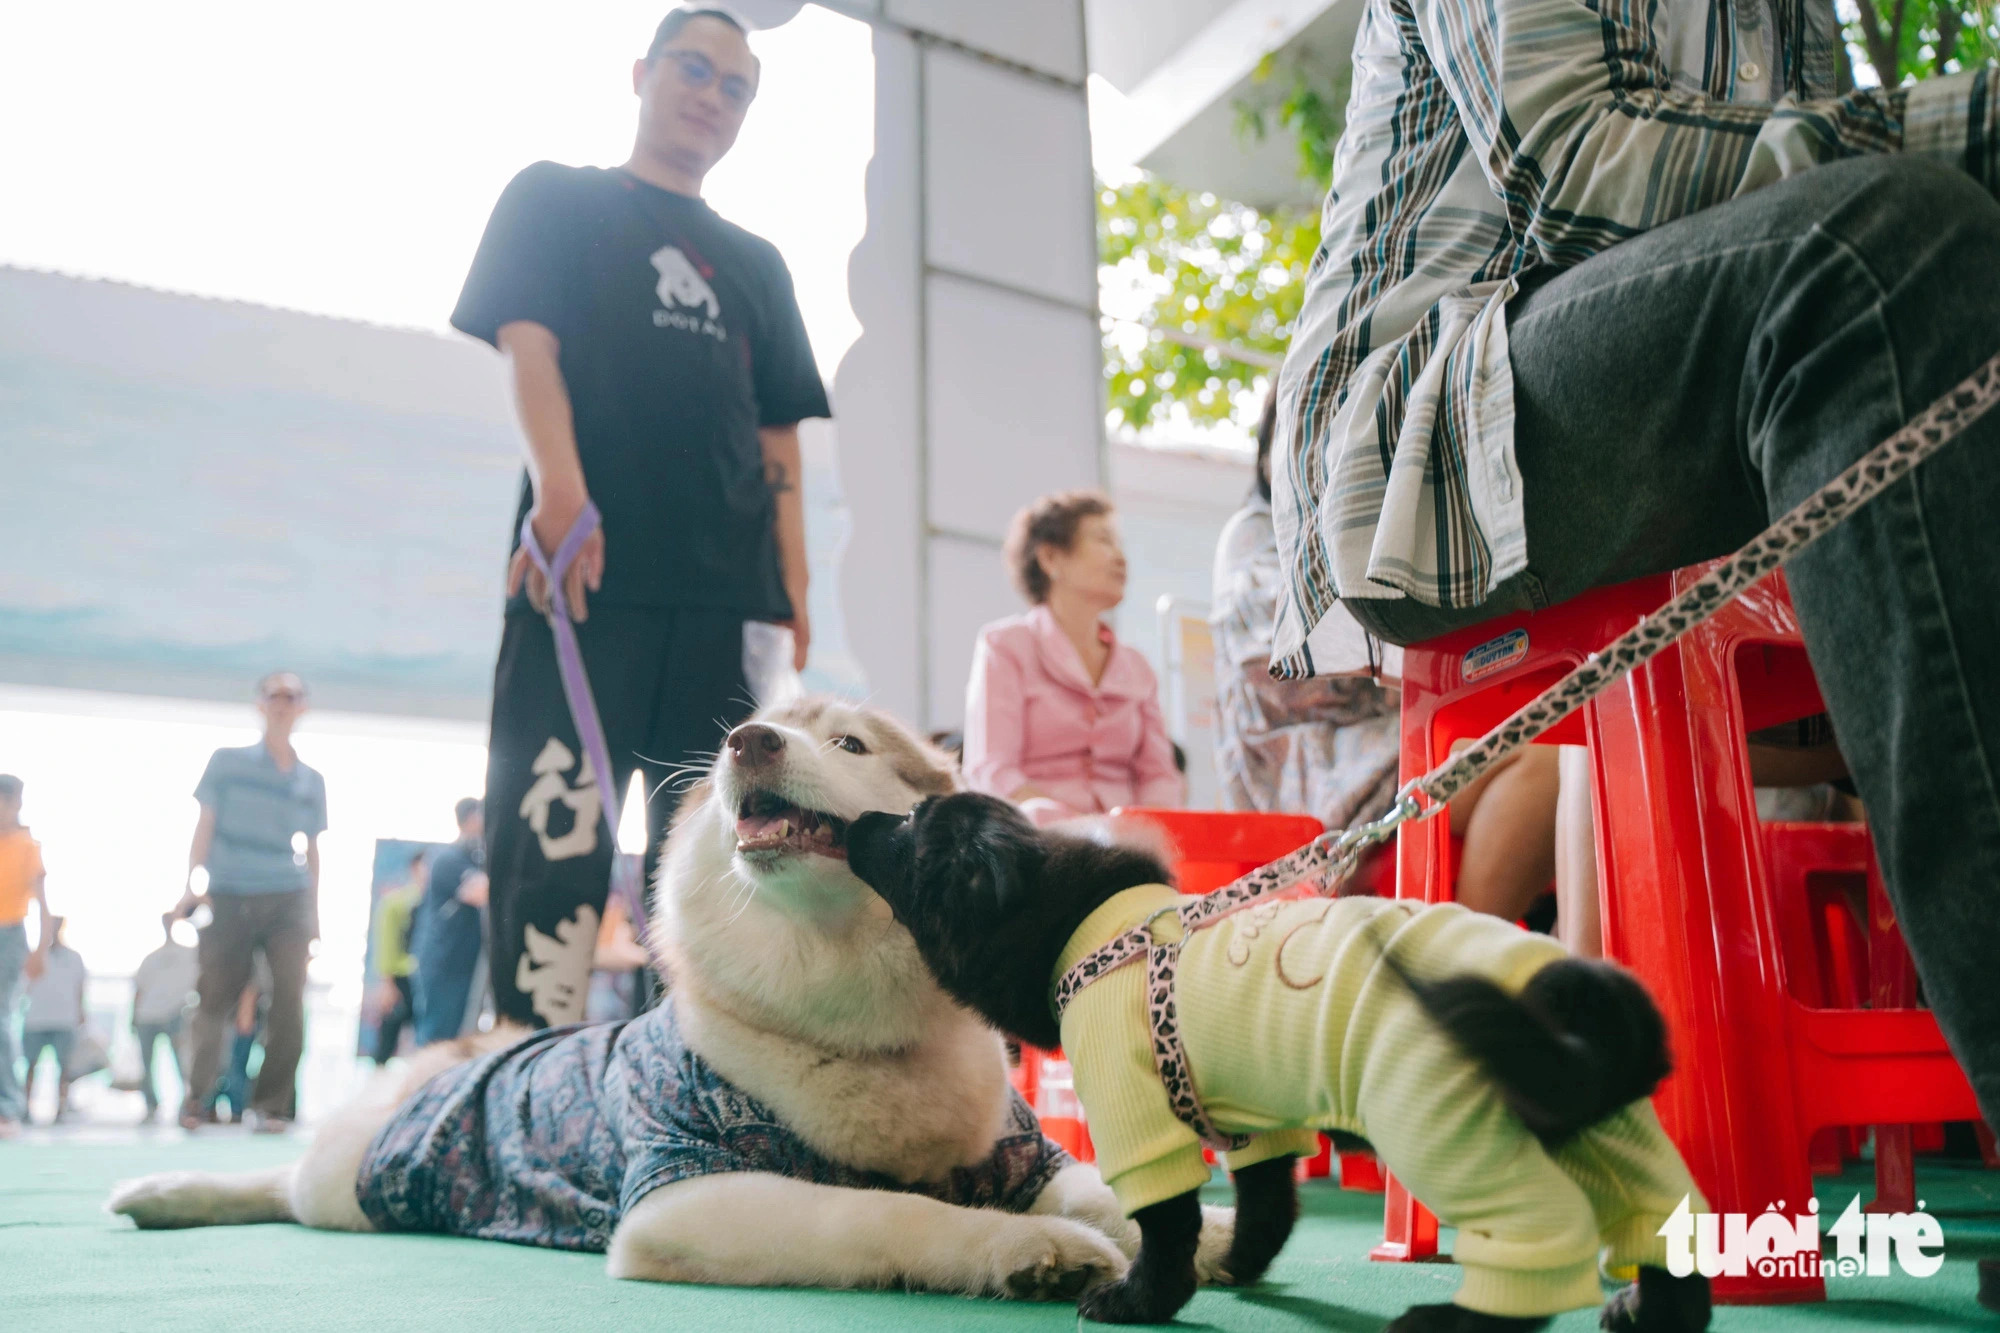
[848,793,1168,1047]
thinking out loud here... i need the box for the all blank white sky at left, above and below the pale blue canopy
[0,0,874,999]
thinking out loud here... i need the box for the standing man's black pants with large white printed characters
[486,606,754,1027]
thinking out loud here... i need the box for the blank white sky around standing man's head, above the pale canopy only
[0,0,874,376]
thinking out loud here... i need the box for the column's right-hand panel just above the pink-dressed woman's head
[928,274,1104,540]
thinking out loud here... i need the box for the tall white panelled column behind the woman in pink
[830,0,1104,729]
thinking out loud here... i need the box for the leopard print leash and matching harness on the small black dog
[1054,354,2000,1151]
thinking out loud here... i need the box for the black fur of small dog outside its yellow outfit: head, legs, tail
[848,795,1710,1333]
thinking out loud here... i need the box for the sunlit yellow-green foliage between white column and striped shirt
[1098,176,1320,428]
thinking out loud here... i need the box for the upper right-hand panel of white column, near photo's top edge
[924,46,1096,308]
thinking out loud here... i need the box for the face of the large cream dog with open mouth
[706,699,956,909]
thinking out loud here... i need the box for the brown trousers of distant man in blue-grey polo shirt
[186,891,312,1119]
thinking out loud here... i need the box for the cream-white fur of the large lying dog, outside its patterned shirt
[110,699,1230,1299]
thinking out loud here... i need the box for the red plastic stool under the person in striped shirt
[1376,568,1978,1301]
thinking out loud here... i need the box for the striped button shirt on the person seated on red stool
[1272,0,2000,677]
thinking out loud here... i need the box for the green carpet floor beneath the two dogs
[0,1135,2000,1333]
